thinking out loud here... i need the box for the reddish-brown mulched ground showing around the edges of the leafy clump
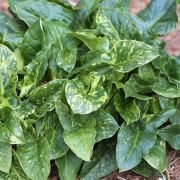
[0,0,180,180]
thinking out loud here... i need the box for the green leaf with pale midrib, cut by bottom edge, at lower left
[16,137,50,180]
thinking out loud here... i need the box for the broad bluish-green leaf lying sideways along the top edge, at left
[15,0,76,26]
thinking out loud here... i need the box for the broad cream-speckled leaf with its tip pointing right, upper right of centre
[112,40,158,73]
